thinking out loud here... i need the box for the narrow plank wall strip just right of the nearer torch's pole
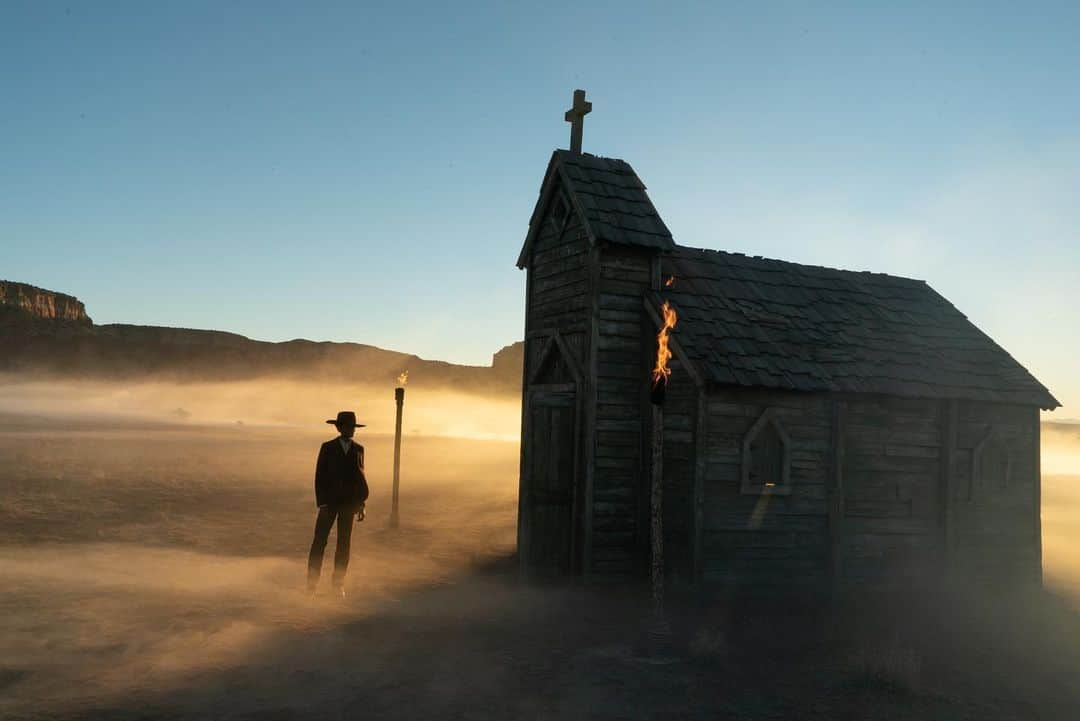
[663,358,698,588]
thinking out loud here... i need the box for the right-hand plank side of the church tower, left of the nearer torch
[590,247,656,582]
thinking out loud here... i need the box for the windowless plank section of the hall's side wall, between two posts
[840,396,944,586]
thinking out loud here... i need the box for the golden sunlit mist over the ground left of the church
[0,381,519,718]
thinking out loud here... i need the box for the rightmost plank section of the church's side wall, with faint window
[949,402,1041,583]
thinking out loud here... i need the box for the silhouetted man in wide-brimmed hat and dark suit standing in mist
[308,410,367,596]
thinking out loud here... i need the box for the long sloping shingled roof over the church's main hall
[654,246,1061,409]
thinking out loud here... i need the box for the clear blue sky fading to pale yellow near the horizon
[0,0,1080,418]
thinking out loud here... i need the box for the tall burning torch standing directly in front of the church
[649,295,678,635]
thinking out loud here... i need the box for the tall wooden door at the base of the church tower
[525,386,577,577]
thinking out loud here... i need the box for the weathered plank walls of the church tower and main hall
[523,193,1041,589]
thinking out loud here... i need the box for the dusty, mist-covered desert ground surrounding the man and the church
[0,379,1080,721]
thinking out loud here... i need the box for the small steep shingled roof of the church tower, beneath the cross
[517,150,675,268]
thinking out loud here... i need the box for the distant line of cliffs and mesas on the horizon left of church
[0,281,523,394]
